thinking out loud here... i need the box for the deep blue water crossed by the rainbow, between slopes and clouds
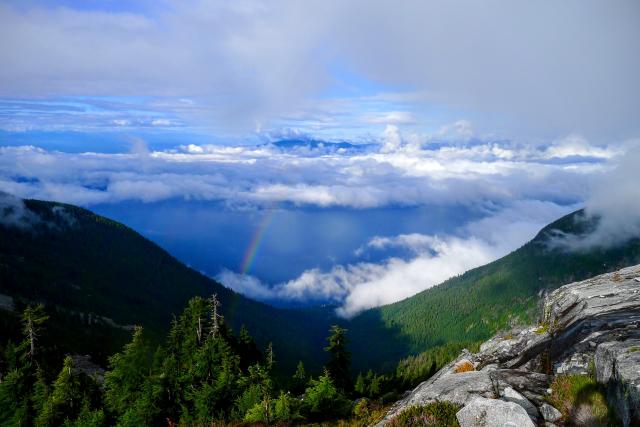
[92,200,479,290]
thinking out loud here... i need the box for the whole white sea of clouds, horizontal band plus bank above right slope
[0,122,640,316]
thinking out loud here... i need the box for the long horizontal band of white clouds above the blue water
[0,131,625,209]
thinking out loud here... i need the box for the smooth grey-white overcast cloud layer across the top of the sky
[0,0,640,139]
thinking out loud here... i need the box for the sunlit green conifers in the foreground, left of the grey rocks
[0,295,459,427]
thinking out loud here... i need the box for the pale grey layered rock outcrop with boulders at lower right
[379,265,640,426]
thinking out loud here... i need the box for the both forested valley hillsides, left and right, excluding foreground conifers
[0,200,640,372]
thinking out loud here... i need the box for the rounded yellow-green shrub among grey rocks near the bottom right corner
[549,375,618,427]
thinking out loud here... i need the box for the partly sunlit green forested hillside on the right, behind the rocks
[349,212,640,369]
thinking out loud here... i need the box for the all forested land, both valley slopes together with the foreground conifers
[0,200,640,425]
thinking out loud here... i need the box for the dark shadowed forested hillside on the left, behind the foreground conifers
[0,200,331,370]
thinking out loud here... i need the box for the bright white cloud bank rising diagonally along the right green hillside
[217,201,574,317]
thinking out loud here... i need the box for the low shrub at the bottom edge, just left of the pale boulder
[388,402,460,427]
